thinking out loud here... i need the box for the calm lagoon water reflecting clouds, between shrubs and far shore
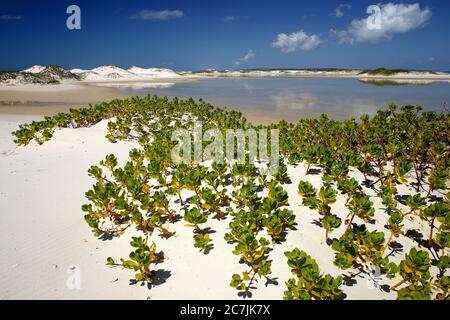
[110,77,450,122]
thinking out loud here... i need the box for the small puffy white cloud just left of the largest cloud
[272,30,321,53]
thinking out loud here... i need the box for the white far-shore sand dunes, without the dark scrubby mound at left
[0,65,450,90]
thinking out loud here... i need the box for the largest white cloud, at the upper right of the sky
[330,2,432,44]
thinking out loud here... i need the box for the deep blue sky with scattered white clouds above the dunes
[0,0,450,71]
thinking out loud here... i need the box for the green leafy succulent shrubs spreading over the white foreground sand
[13,96,450,300]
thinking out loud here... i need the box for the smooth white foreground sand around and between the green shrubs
[0,115,438,299]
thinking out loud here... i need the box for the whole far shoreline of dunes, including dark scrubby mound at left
[0,65,450,87]
